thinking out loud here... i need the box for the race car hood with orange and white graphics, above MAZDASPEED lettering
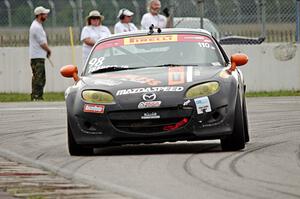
[82,66,224,90]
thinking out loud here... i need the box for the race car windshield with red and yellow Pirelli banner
[84,34,224,74]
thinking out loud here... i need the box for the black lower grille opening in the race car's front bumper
[111,117,188,133]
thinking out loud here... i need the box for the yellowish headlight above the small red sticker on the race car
[82,90,115,104]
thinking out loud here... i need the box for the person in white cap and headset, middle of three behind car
[114,8,137,33]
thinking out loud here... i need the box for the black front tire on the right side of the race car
[221,95,245,151]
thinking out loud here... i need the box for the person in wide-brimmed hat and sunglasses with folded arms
[80,10,111,63]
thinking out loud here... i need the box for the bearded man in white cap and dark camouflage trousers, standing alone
[29,6,51,101]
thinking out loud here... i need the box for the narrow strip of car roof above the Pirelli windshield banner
[97,28,211,44]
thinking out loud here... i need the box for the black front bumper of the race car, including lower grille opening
[68,98,234,147]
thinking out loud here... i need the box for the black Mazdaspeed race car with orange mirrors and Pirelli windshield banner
[61,29,249,155]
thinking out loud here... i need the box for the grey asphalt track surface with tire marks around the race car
[0,97,300,199]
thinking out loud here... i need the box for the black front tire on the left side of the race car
[68,123,94,156]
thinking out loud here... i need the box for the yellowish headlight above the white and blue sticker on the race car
[185,82,220,99]
